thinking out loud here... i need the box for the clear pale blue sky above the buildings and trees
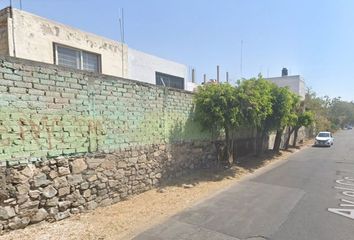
[0,0,354,101]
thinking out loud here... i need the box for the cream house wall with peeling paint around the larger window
[8,9,128,77]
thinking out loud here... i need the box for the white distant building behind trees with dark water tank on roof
[265,68,306,100]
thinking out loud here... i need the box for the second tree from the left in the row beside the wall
[236,75,274,155]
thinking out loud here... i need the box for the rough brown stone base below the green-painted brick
[0,143,215,230]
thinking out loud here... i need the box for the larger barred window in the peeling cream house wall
[54,44,101,72]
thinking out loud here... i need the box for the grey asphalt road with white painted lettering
[135,130,354,240]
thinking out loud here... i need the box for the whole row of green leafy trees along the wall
[194,75,318,156]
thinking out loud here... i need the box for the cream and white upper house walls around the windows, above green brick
[0,8,196,91]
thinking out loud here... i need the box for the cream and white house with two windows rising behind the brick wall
[0,7,196,91]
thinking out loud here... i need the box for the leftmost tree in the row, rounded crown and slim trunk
[194,83,240,164]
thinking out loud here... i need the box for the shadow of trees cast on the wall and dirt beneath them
[158,114,279,188]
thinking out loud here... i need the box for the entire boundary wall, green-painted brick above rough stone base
[0,57,215,230]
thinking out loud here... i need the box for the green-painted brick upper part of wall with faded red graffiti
[0,57,210,164]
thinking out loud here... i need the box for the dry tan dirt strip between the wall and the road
[0,142,310,240]
